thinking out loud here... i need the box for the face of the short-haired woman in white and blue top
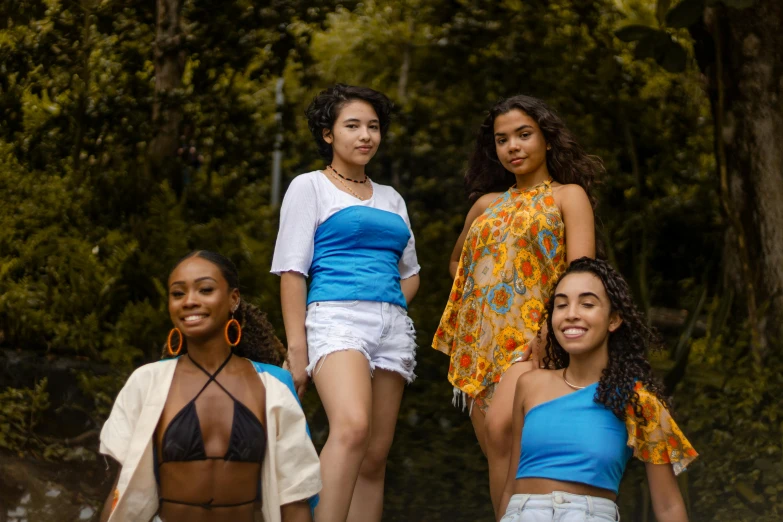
[323,100,381,166]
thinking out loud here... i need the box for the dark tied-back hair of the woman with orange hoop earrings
[163,250,286,366]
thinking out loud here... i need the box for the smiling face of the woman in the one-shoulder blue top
[552,272,623,356]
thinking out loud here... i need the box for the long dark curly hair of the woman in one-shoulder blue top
[544,257,669,422]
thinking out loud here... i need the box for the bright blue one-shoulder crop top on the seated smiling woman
[517,383,633,493]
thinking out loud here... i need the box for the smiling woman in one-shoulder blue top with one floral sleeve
[500,258,697,522]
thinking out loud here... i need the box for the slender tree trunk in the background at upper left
[148,0,185,188]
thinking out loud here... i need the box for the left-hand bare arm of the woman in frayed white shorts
[280,272,308,397]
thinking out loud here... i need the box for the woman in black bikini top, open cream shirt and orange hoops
[100,250,321,522]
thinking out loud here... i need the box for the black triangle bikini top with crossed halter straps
[161,354,266,464]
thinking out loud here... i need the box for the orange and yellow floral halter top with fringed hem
[432,181,566,410]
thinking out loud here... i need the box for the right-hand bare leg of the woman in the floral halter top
[485,361,533,519]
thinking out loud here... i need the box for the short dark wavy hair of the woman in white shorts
[305,83,394,162]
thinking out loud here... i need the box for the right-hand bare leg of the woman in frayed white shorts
[348,369,405,522]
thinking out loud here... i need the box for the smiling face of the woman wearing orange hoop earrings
[169,256,239,341]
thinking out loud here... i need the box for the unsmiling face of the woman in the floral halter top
[494,109,549,183]
